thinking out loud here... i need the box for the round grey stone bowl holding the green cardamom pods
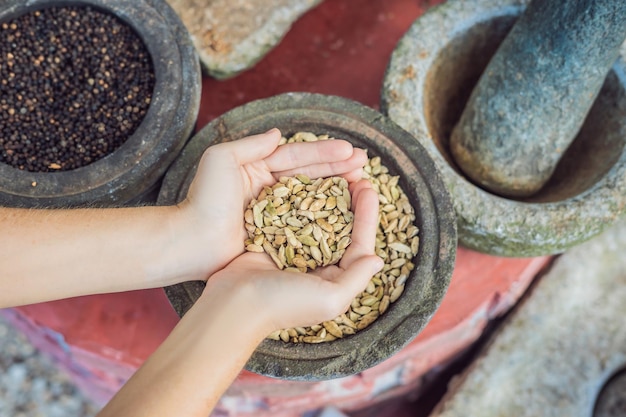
[158,93,457,381]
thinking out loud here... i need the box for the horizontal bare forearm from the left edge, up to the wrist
[0,207,210,307]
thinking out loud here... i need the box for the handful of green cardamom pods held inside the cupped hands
[244,175,354,272]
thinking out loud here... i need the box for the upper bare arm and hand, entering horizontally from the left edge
[0,130,367,307]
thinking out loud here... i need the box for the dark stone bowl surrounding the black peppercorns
[0,0,201,207]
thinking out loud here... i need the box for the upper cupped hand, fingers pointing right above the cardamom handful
[174,129,367,280]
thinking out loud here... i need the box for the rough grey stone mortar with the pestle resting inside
[382,0,626,257]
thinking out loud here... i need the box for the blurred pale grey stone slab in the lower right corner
[431,216,626,417]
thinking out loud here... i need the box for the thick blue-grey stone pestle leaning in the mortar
[450,0,626,198]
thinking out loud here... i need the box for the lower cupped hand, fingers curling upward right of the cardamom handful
[199,181,383,335]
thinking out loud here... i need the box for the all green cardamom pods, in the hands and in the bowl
[244,132,419,343]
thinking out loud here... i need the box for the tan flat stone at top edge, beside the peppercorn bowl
[167,0,322,79]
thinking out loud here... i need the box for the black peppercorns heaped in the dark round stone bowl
[0,7,155,172]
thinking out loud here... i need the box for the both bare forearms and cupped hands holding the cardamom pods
[0,129,383,417]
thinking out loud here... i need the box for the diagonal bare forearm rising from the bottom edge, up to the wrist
[99,282,269,417]
